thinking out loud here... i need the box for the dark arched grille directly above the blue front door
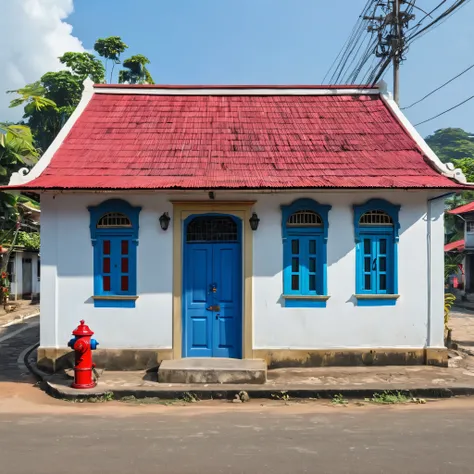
[186,216,238,242]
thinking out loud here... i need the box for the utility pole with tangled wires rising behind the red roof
[364,0,415,104]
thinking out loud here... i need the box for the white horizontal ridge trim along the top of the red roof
[94,87,380,96]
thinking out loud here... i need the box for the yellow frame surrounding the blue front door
[171,201,255,359]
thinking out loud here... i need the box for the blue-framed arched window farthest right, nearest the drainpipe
[354,199,400,306]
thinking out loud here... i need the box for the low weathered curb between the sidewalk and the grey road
[44,381,474,401]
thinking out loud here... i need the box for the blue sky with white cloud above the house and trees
[0,0,474,136]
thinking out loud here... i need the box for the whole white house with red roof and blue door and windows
[3,80,466,368]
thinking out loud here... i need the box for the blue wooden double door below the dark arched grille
[183,218,242,358]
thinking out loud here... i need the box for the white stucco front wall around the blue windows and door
[41,191,443,349]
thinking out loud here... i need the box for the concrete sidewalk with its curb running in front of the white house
[28,353,474,399]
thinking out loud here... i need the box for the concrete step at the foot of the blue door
[158,357,267,384]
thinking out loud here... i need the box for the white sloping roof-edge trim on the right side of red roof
[381,93,468,185]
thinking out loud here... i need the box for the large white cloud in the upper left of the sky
[0,0,84,122]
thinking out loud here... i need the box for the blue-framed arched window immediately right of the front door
[282,199,331,307]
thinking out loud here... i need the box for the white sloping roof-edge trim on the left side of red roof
[8,78,94,186]
